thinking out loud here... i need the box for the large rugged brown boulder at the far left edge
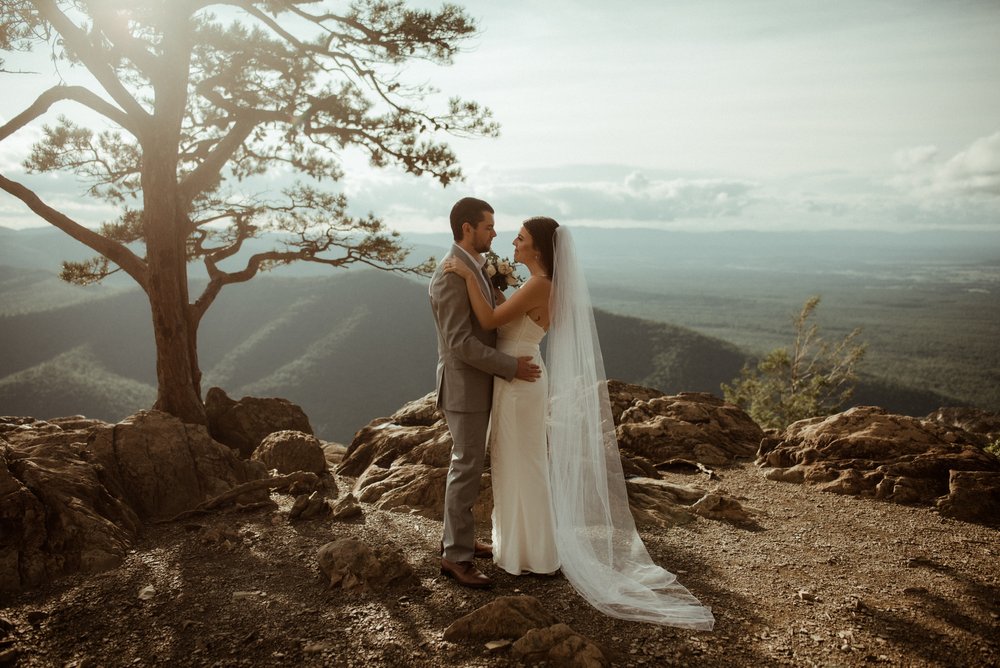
[0,418,140,590]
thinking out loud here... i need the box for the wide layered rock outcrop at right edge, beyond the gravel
[757,406,1000,522]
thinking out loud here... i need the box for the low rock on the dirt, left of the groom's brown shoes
[317,538,413,589]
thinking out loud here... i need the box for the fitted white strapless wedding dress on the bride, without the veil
[489,315,559,575]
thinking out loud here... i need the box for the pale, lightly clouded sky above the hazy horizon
[0,0,1000,232]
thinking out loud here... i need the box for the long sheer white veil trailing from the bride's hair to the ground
[546,227,715,630]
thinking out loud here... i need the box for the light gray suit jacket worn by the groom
[428,246,517,413]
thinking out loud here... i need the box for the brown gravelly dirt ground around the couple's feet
[0,464,1000,668]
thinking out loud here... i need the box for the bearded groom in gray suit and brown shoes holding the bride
[429,197,541,587]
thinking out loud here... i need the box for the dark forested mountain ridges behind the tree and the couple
[0,270,745,440]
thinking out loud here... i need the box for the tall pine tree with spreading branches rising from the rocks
[0,0,497,423]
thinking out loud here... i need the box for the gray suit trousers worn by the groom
[444,410,490,562]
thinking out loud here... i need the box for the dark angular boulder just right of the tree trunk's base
[205,387,313,458]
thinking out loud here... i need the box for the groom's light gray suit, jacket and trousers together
[428,246,517,562]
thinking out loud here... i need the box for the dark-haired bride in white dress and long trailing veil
[444,217,715,630]
